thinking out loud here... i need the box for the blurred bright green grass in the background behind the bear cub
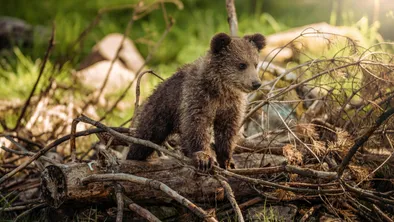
[0,0,384,128]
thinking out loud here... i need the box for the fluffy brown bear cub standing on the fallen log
[127,33,265,170]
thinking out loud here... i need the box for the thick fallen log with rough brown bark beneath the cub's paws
[41,154,282,208]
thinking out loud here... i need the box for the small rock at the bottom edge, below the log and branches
[245,205,297,221]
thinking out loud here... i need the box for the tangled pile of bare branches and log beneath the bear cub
[0,103,394,221]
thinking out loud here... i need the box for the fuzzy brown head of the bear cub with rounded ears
[210,33,265,92]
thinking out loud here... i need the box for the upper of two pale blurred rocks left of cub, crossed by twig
[80,33,145,73]
